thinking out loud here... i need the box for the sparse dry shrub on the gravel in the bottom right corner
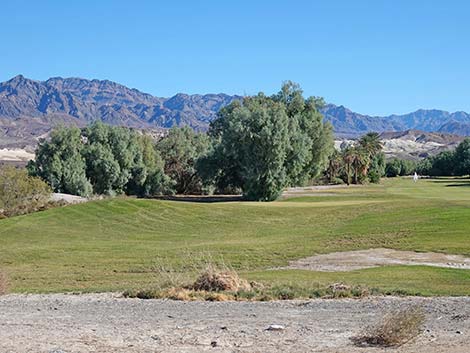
[352,306,425,347]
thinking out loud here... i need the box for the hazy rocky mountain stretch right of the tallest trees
[322,104,470,137]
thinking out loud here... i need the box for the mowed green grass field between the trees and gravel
[0,178,470,295]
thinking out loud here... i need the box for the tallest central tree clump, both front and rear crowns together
[199,82,333,201]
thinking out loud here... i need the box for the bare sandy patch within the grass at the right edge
[284,248,470,272]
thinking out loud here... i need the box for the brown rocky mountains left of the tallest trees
[0,75,242,147]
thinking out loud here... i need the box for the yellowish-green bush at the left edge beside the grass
[0,167,51,217]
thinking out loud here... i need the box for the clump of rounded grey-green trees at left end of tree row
[28,122,171,196]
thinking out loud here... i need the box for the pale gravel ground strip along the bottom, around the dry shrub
[0,294,470,353]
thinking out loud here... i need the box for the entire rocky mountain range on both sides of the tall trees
[0,75,470,148]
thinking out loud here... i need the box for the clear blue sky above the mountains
[0,0,470,115]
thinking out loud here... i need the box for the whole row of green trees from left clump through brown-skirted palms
[28,82,385,201]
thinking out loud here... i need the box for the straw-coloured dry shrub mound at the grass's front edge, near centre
[190,265,251,292]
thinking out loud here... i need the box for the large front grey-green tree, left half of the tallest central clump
[203,93,289,201]
